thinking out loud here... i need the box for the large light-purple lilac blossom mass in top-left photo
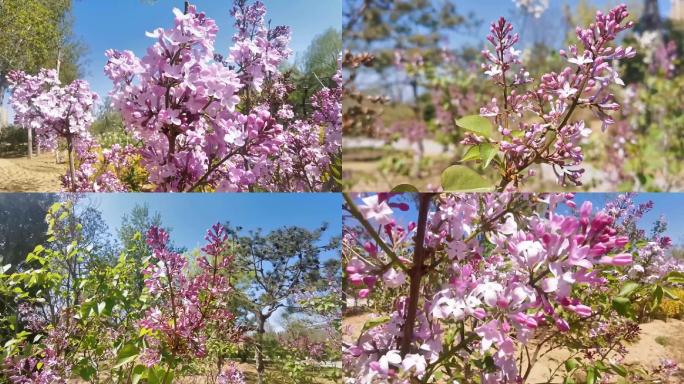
[105,0,341,191]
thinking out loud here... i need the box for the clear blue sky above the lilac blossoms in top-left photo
[69,0,342,98]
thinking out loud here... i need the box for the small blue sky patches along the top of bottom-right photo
[356,193,684,246]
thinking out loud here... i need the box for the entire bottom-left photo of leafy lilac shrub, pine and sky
[0,194,341,384]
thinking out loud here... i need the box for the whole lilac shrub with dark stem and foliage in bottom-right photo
[343,193,683,383]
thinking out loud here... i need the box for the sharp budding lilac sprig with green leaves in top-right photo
[442,5,635,191]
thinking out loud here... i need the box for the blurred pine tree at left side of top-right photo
[343,0,477,173]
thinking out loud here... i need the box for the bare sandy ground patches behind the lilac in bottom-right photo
[342,314,684,384]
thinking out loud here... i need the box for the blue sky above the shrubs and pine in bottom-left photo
[84,193,342,258]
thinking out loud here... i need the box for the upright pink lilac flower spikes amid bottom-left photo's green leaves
[140,224,234,366]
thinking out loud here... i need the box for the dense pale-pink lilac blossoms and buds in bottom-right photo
[344,194,634,383]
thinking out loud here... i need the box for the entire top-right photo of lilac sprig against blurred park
[343,0,684,192]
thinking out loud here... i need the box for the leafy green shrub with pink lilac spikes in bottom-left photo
[0,203,244,384]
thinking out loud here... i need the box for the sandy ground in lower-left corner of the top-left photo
[0,153,66,192]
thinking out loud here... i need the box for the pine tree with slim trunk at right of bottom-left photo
[233,225,339,384]
